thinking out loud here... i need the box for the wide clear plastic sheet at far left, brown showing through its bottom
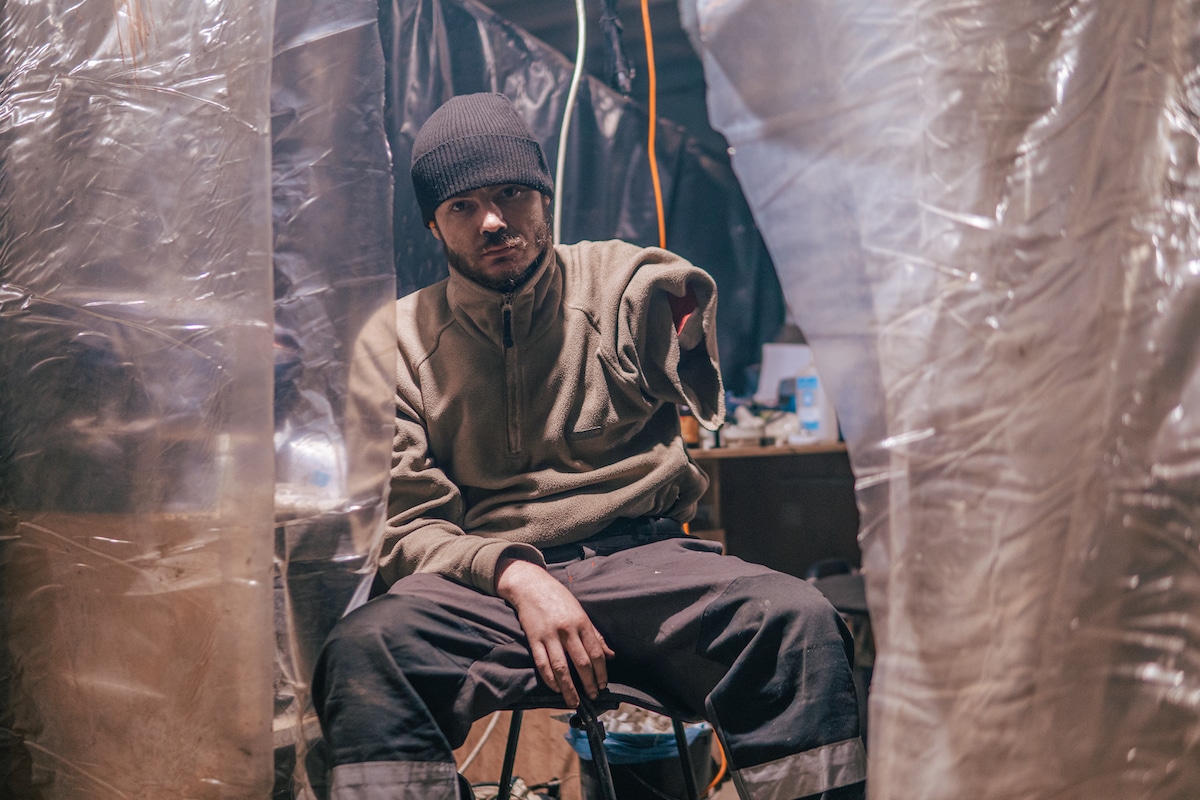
[0,2,274,800]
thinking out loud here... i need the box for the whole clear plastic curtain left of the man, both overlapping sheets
[0,0,395,800]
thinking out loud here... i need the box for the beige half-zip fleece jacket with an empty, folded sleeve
[379,241,725,594]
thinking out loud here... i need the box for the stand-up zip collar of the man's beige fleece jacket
[446,247,563,348]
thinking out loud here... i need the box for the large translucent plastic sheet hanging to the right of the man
[684,0,1200,800]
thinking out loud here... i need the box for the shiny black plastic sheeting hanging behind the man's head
[379,0,784,392]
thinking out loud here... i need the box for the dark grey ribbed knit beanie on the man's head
[413,94,554,224]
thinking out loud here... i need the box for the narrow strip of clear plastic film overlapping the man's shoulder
[271,0,396,798]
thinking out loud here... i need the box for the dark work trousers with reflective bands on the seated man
[313,523,865,800]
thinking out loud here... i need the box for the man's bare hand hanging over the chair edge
[496,558,613,709]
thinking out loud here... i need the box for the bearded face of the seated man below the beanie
[430,184,551,291]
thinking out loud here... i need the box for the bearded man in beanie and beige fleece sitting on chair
[314,94,865,800]
